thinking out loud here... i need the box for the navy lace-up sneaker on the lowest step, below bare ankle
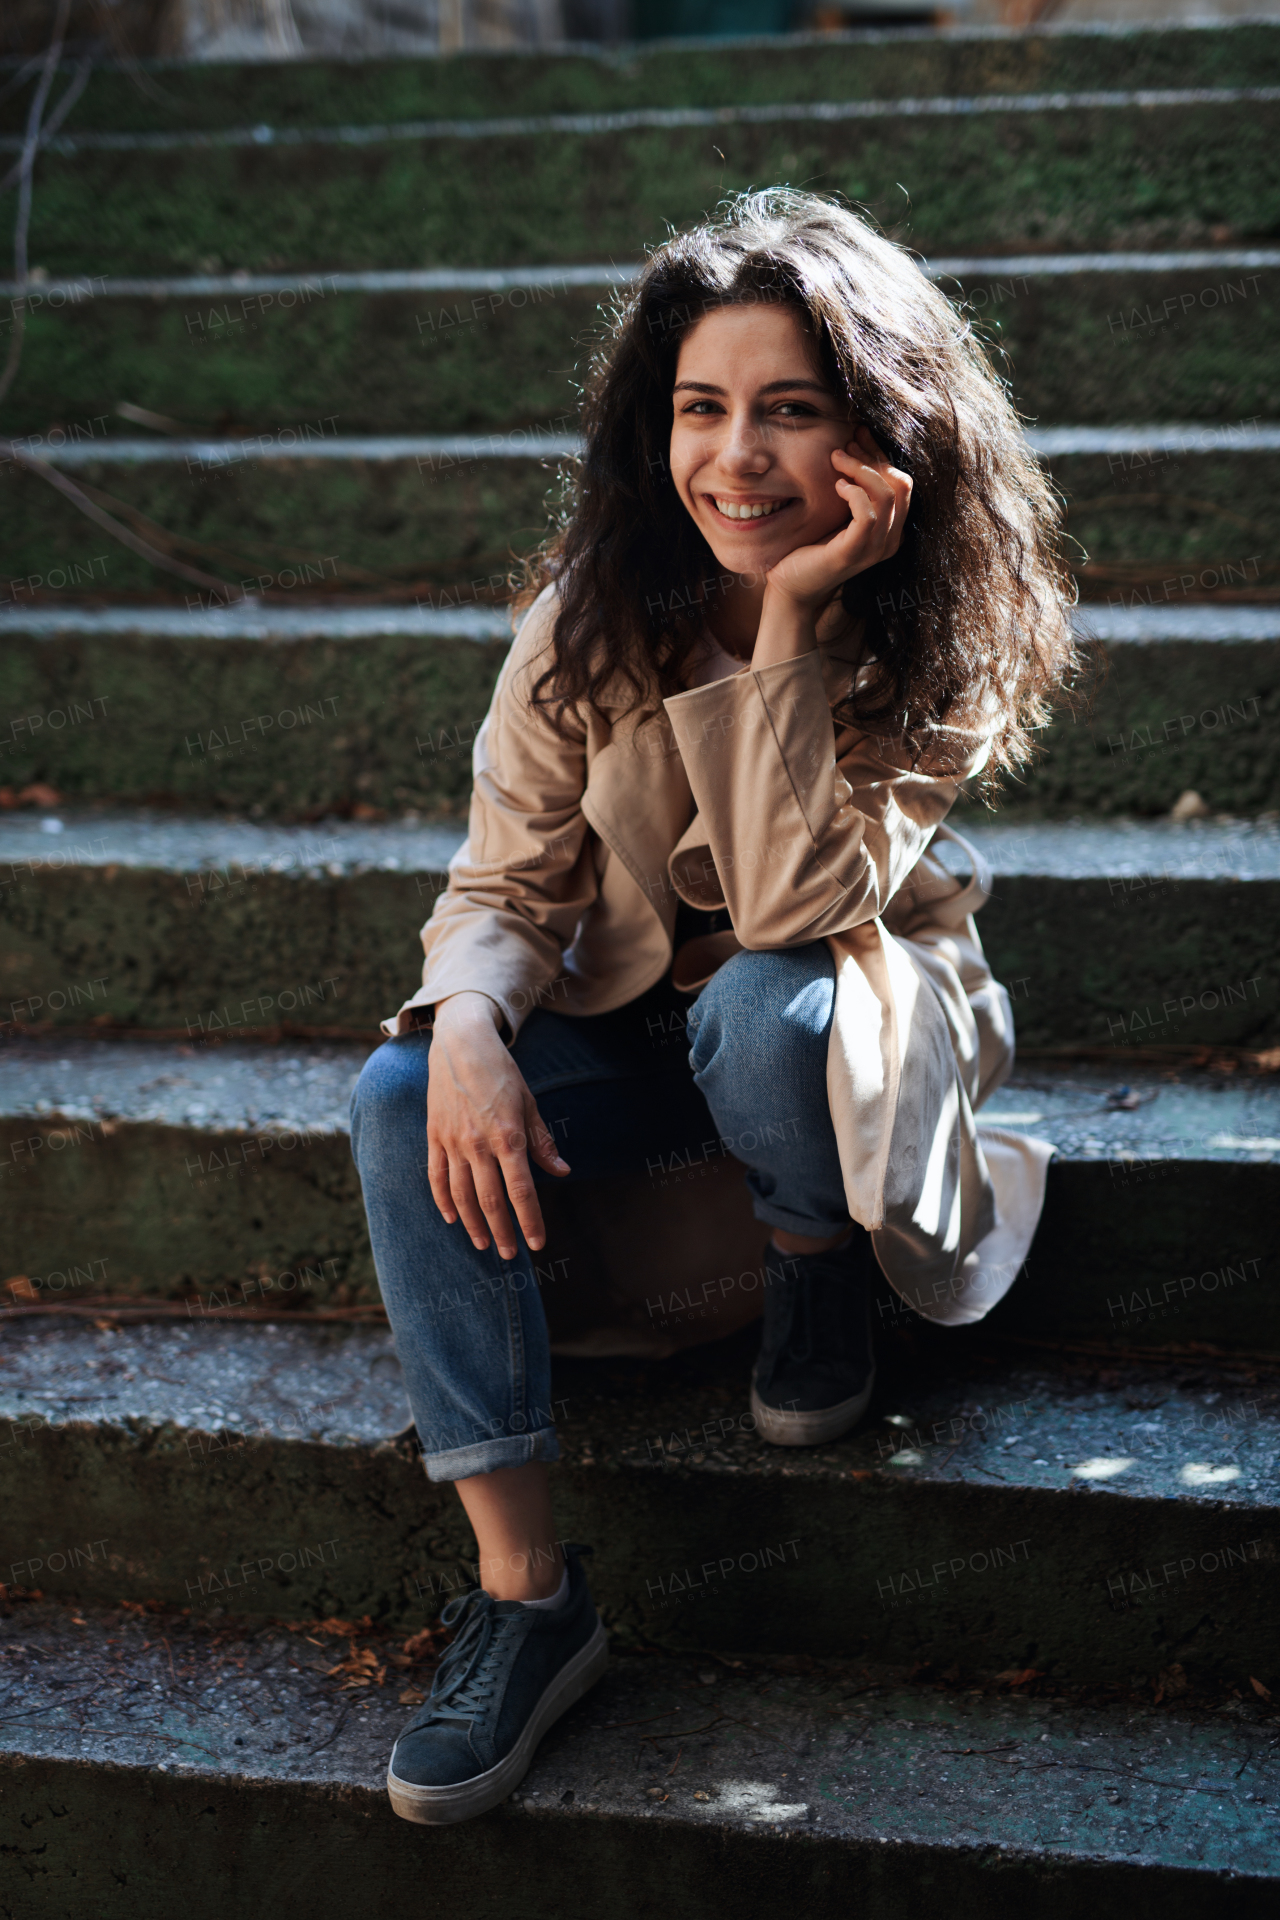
[386,1546,608,1826]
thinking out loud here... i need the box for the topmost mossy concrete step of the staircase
[0,19,1280,136]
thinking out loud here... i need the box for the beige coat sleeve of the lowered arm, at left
[382,589,597,1041]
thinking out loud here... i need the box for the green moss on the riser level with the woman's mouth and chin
[0,453,1280,603]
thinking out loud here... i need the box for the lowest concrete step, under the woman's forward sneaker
[0,1601,1280,1920]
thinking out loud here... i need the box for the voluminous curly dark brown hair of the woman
[524,188,1079,783]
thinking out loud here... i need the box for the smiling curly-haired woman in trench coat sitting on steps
[353,192,1073,1822]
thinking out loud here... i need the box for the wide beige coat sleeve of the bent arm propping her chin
[664,651,977,948]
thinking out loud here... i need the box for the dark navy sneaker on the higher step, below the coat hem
[750,1227,875,1446]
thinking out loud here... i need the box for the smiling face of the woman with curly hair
[670,305,856,576]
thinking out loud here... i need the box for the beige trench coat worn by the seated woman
[384,589,1054,1325]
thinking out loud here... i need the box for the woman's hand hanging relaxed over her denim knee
[426,993,568,1260]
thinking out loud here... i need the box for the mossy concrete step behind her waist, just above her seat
[0,814,1280,1058]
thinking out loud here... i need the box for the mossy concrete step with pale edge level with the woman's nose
[0,439,1280,609]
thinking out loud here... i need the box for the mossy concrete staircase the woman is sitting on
[0,25,1280,1920]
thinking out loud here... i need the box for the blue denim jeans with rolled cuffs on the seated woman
[351,941,848,1480]
